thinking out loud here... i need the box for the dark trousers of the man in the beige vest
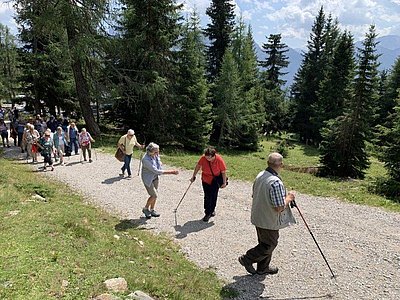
[244,227,279,272]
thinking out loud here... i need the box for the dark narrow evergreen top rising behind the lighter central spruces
[204,0,235,82]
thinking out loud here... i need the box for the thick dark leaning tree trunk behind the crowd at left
[66,22,100,136]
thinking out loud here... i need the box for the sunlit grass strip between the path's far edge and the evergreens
[162,140,400,212]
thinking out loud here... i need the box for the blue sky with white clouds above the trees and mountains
[0,0,400,48]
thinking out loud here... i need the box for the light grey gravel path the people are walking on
[6,148,400,300]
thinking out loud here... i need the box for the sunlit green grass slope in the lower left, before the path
[0,158,235,300]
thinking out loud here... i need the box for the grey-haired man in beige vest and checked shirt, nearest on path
[239,153,296,275]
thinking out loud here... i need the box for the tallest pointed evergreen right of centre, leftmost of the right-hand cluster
[291,7,326,142]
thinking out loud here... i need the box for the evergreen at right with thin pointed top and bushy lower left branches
[320,25,379,178]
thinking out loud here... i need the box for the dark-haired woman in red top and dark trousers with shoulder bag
[190,147,227,222]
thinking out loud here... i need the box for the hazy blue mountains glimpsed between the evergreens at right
[255,35,400,86]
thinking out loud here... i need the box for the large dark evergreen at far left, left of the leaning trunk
[15,0,74,115]
